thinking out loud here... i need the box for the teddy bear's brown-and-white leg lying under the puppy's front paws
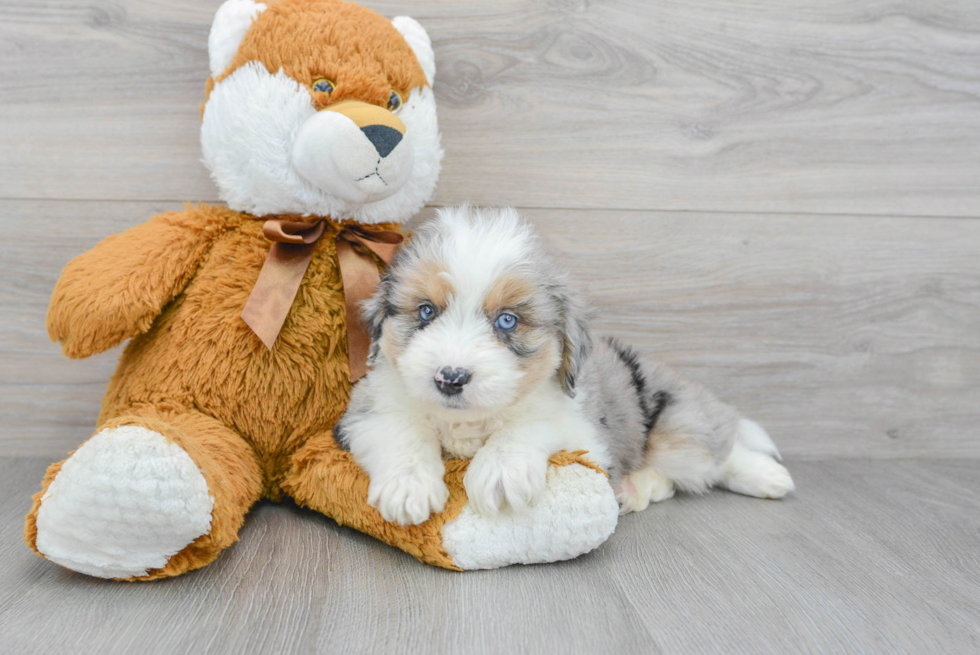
[284,434,619,570]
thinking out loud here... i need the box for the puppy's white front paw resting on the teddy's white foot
[463,448,548,516]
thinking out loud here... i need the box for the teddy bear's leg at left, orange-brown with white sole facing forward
[24,407,262,580]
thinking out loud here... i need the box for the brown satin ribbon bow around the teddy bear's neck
[242,219,403,382]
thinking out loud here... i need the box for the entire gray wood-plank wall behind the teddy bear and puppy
[0,0,980,459]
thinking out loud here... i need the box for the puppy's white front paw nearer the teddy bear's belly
[368,471,449,525]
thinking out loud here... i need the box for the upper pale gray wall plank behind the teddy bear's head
[0,0,980,216]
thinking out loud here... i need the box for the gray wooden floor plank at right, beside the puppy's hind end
[602,461,980,653]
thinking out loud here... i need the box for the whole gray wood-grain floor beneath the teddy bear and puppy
[0,459,980,655]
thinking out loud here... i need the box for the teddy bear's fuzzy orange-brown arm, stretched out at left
[47,206,228,359]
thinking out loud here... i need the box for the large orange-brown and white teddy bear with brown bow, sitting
[25,0,618,580]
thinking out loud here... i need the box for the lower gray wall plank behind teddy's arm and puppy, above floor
[0,201,980,458]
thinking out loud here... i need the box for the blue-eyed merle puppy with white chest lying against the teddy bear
[334,206,793,525]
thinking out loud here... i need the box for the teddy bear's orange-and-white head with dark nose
[201,0,442,223]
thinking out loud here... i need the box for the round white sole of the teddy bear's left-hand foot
[36,425,214,578]
